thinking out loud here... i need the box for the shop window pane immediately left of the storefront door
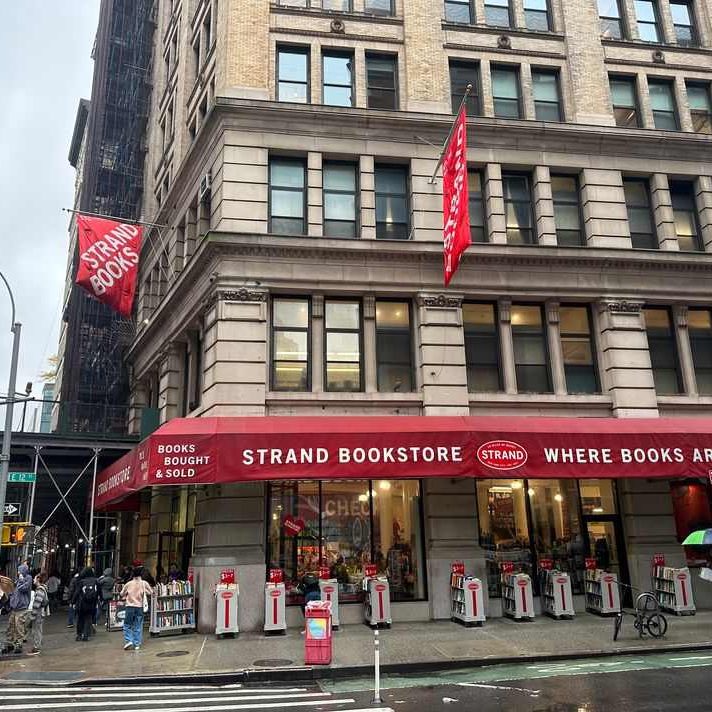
[527,480,585,593]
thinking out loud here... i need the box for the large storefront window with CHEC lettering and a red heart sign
[267,480,426,605]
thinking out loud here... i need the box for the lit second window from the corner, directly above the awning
[324,299,363,392]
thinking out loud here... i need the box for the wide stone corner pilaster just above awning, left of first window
[200,287,268,416]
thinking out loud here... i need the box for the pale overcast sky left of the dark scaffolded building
[0,0,99,422]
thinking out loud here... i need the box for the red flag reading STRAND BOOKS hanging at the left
[77,215,143,317]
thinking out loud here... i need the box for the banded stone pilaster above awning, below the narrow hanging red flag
[418,293,470,415]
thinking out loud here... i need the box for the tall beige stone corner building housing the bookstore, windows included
[110,0,712,628]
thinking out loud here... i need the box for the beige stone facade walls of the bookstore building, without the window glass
[125,0,712,628]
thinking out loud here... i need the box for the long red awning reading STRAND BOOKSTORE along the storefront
[96,416,712,509]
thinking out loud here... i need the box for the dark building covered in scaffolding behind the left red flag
[54,0,156,433]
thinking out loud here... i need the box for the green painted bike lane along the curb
[320,651,712,693]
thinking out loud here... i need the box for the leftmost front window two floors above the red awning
[269,158,306,235]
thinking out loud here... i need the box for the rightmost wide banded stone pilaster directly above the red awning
[597,299,658,418]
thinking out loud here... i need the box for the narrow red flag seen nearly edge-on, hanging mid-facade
[443,106,472,286]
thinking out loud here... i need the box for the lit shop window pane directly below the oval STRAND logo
[477,480,532,597]
